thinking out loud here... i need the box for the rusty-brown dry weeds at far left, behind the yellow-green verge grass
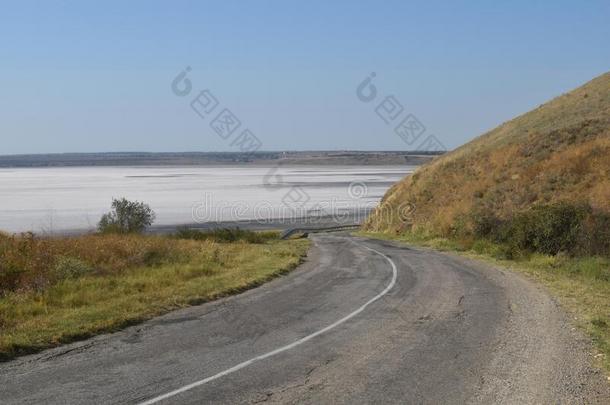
[0,233,193,296]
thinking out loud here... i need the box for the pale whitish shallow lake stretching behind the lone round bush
[0,166,414,233]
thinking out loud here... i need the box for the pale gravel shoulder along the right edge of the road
[356,234,610,403]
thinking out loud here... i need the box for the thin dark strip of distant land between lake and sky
[0,151,442,168]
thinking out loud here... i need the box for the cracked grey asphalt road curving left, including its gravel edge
[0,234,610,404]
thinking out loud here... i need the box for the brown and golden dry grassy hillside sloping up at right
[366,73,610,236]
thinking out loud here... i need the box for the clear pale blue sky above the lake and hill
[0,0,610,154]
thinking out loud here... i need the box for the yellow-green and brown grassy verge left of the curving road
[0,235,308,359]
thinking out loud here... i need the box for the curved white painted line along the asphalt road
[140,244,398,405]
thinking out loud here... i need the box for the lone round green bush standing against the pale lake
[97,198,155,234]
